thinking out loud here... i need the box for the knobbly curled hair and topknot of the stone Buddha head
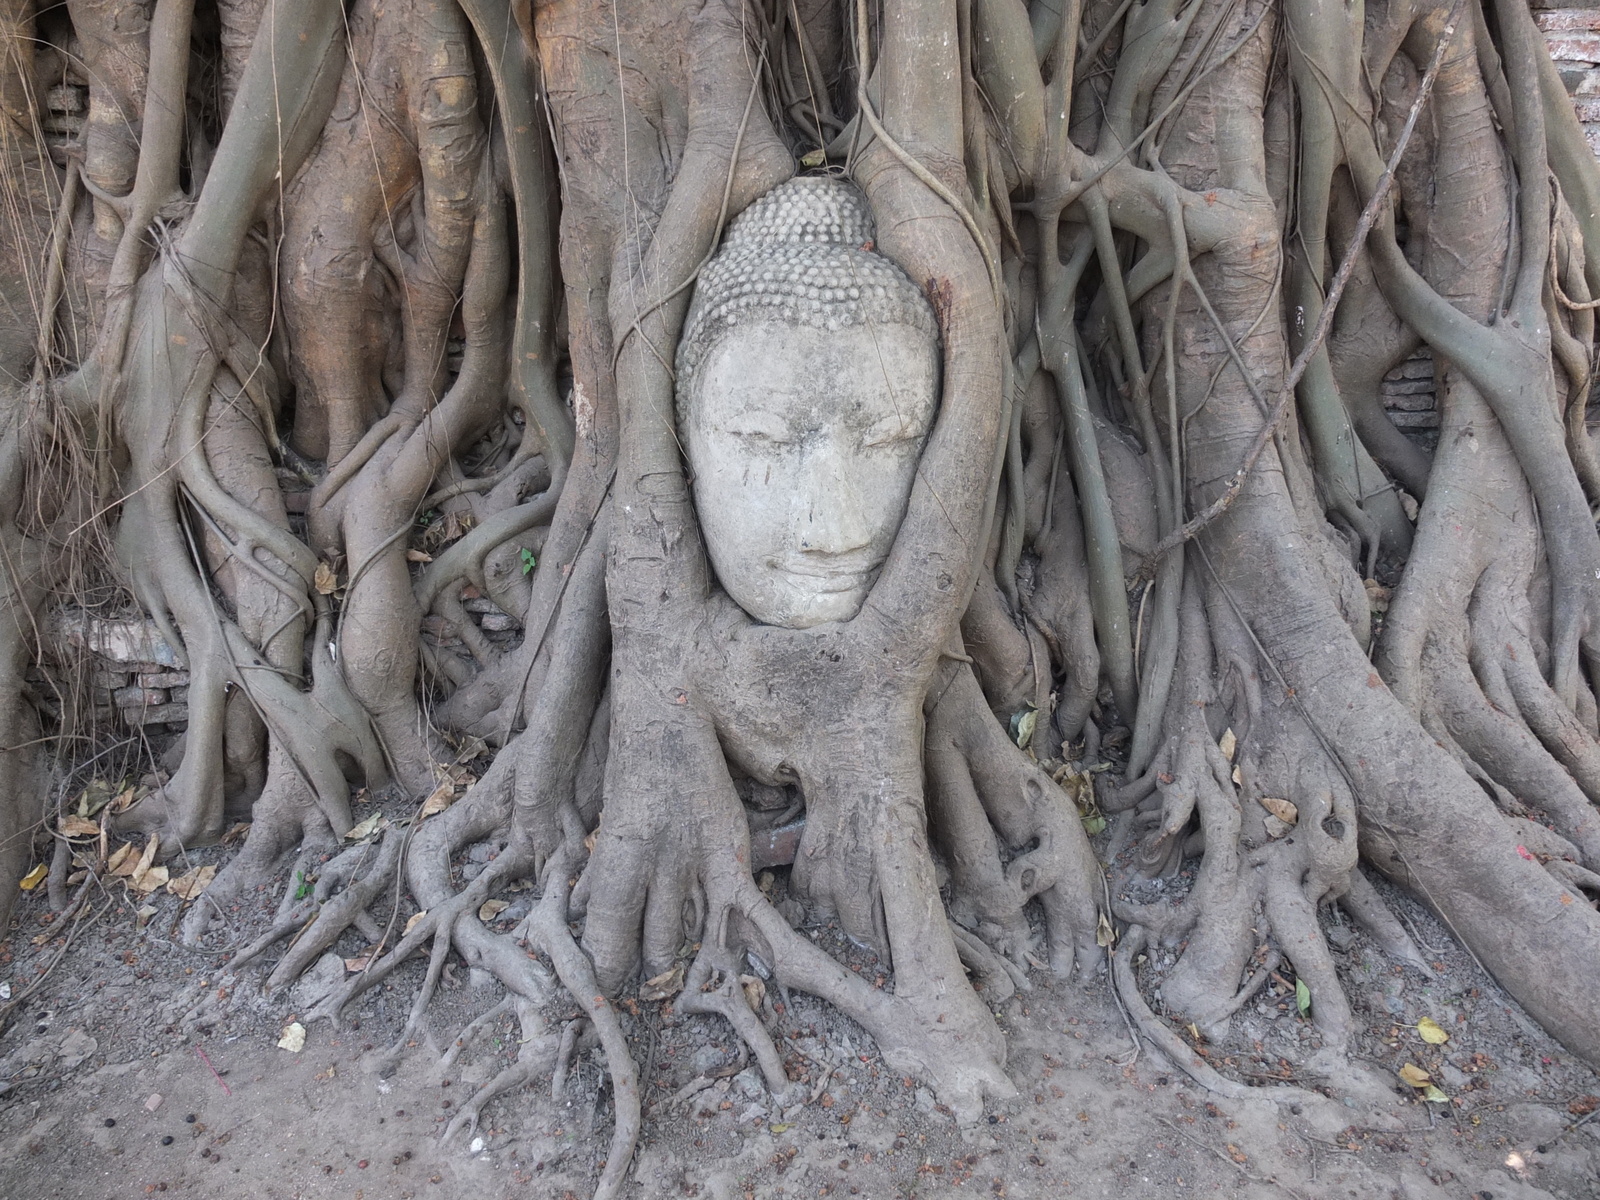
[677,174,939,395]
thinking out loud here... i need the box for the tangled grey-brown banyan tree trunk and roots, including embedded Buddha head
[0,0,1600,1195]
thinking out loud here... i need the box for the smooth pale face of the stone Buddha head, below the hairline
[682,322,939,629]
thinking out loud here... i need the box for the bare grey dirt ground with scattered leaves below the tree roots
[0,825,1600,1200]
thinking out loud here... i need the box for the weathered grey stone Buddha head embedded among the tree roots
[677,176,939,629]
